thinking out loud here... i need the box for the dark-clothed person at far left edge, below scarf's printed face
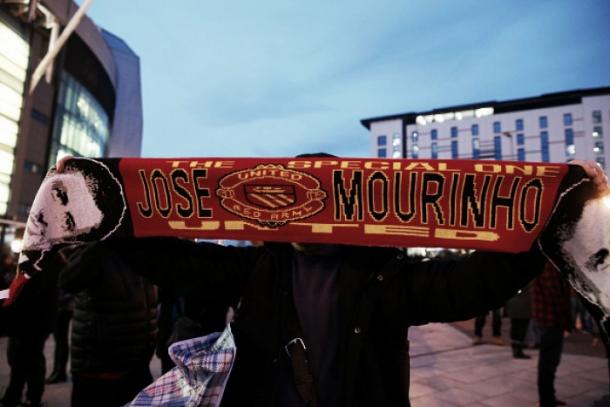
[0,256,58,407]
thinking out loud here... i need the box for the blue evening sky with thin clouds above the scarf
[88,0,610,157]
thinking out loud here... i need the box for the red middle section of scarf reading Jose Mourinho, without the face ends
[121,158,568,252]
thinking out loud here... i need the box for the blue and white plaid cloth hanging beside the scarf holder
[125,325,236,407]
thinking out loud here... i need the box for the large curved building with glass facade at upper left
[0,0,142,249]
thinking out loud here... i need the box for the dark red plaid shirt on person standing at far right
[532,262,572,331]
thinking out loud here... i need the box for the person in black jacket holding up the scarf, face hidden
[66,238,543,407]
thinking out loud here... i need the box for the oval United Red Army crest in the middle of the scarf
[216,164,327,228]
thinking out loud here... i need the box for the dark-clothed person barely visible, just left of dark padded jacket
[45,289,74,384]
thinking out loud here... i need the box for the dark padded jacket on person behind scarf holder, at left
[59,244,157,374]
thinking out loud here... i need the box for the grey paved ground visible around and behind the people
[0,323,609,407]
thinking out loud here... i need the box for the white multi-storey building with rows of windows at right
[361,87,610,168]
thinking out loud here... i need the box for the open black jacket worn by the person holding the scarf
[66,238,542,406]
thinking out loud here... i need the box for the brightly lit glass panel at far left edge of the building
[0,14,30,216]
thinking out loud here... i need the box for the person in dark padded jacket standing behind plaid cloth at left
[59,244,157,407]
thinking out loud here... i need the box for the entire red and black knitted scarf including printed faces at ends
[0,158,610,334]
